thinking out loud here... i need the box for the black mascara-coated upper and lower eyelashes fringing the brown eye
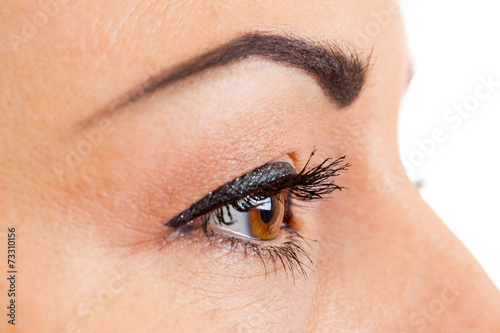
[174,150,350,280]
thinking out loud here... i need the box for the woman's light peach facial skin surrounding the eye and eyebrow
[0,0,500,332]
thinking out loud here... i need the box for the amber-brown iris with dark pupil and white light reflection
[249,194,285,240]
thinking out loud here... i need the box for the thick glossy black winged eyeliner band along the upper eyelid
[165,162,297,228]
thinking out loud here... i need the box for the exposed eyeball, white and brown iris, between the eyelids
[208,193,286,240]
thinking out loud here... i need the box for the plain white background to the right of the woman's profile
[399,0,500,287]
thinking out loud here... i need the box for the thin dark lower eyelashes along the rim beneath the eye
[203,227,316,281]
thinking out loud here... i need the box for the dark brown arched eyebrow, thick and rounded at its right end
[87,34,369,123]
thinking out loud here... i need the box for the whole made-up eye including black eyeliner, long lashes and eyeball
[164,151,349,276]
